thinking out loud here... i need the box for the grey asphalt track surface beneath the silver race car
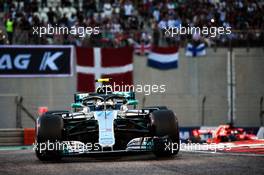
[0,150,264,175]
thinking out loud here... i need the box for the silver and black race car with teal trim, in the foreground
[35,79,180,160]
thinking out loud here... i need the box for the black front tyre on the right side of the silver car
[150,110,180,157]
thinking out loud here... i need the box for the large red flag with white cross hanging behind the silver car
[76,47,133,92]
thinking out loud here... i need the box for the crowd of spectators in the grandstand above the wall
[0,0,264,47]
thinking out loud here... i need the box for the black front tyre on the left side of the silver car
[35,114,63,161]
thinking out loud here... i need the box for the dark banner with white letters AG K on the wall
[0,45,73,77]
